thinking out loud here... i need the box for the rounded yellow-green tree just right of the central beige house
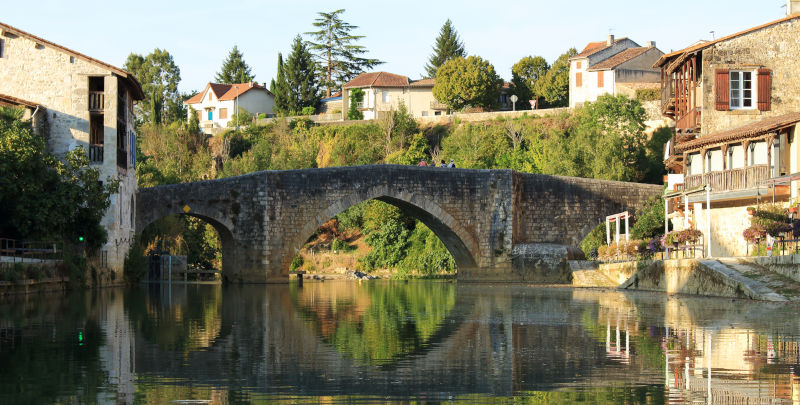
[433,56,503,110]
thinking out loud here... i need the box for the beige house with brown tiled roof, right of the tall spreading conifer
[342,72,447,120]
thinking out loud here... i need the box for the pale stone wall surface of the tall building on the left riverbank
[0,25,136,278]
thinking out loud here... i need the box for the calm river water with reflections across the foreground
[0,281,800,404]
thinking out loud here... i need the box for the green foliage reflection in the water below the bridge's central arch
[292,282,456,365]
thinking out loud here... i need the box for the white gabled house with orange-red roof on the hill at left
[184,82,275,134]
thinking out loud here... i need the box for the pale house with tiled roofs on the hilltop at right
[569,35,664,107]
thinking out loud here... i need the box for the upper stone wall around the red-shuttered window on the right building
[702,19,800,134]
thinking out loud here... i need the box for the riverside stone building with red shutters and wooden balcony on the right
[654,0,800,256]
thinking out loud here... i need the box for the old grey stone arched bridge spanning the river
[136,165,662,283]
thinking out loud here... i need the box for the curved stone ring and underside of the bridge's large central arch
[282,186,479,271]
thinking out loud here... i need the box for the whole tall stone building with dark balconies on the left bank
[0,23,144,280]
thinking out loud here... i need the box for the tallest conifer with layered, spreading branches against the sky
[305,9,383,97]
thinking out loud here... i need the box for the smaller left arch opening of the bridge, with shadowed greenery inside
[136,213,233,280]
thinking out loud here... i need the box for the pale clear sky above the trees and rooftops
[0,0,786,92]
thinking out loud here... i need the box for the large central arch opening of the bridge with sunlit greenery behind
[286,192,477,278]
